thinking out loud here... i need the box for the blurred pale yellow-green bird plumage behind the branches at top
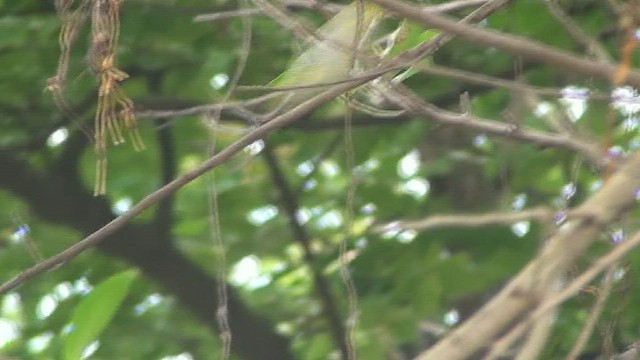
[269,2,384,111]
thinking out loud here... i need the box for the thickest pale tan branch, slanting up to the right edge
[417,154,640,360]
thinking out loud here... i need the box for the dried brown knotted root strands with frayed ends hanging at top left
[47,0,144,195]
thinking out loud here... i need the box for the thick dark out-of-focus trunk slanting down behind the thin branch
[0,148,294,360]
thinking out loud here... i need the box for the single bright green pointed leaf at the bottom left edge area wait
[64,270,138,360]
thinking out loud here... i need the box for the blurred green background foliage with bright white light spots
[0,0,640,360]
